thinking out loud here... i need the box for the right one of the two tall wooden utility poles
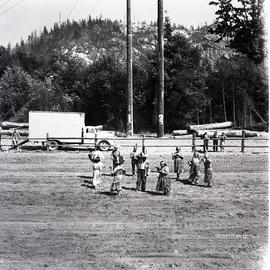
[157,0,164,137]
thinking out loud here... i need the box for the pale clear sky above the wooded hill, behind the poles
[0,0,216,46]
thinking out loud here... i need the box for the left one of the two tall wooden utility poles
[127,0,133,137]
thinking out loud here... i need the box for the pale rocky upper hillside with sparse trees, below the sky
[15,18,233,68]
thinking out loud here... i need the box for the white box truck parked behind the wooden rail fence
[29,111,115,151]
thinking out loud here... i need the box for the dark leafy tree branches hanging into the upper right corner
[209,0,265,64]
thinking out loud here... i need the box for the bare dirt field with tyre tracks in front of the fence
[0,144,268,270]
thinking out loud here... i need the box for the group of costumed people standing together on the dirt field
[89,145,213,196]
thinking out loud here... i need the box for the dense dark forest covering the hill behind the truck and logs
[0,12,268,131]
